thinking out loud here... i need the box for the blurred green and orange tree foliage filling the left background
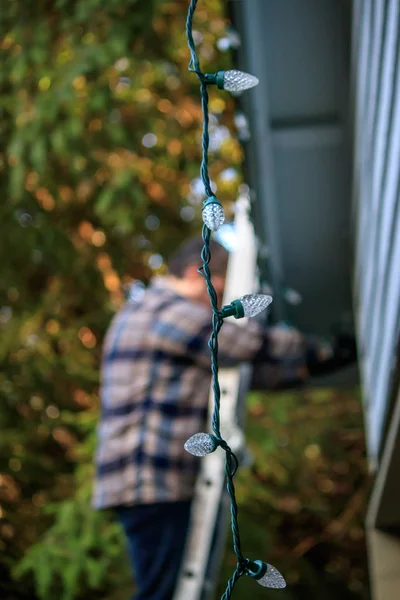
[0,0,242,600]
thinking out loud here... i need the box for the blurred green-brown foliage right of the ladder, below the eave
[220,389,369,600]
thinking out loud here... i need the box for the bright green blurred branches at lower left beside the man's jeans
[14,411,132,600]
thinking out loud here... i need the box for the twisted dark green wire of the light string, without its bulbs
[186,0,248,600]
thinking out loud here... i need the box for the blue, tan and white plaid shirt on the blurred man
[93,283,263,508]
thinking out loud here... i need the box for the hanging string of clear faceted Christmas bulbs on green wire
[185,0,286,600]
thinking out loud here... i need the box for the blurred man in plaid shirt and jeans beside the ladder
[94,239,346,600]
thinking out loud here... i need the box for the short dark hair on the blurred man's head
[168,237,229,278]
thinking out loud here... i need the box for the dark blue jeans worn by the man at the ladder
[116,501,190,600]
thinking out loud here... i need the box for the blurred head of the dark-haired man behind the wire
[168,237,228,304]
